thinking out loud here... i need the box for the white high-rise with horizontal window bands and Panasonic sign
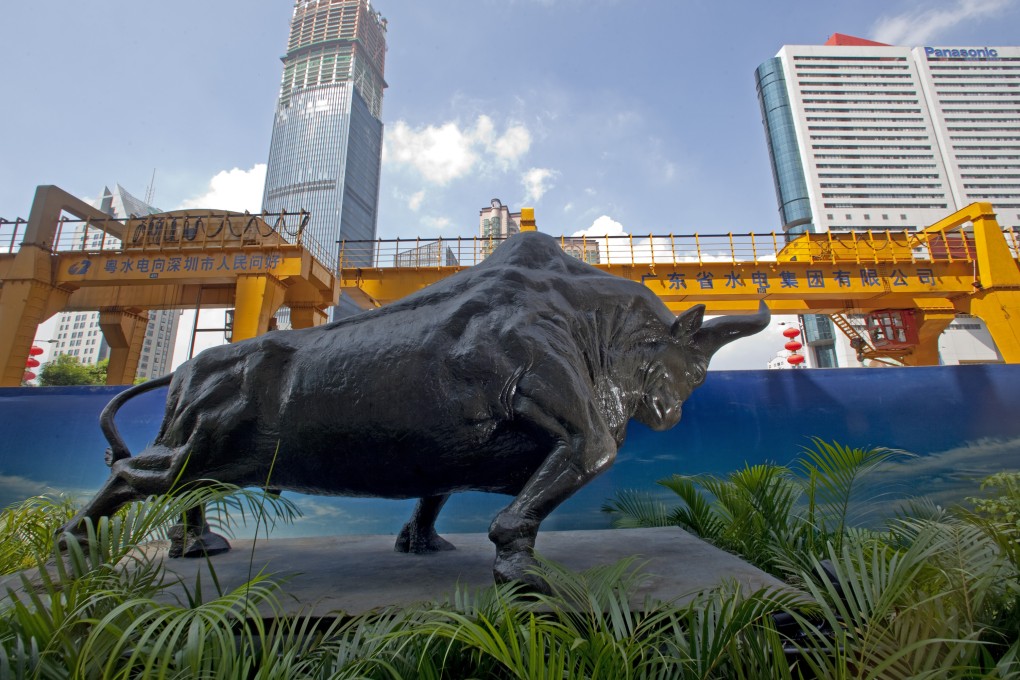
[755,34,1020,367]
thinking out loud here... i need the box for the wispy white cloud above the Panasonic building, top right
[872,0,1013,47]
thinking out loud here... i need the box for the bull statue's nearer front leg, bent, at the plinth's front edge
[489,403,616,591]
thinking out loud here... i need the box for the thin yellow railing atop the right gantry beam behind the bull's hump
[339,228,1020,269]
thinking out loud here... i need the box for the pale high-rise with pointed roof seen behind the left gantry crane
[48,185,181,378]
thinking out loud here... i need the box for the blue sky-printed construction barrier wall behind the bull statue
[0,365,1020,536]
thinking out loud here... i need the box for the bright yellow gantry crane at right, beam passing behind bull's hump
[340,203,1020,366]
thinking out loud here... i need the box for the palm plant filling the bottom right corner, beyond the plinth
[783,521,1020,678]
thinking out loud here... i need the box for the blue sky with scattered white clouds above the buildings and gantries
[0,0,1020,369]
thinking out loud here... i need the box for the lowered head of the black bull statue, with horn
[634,302,771,430]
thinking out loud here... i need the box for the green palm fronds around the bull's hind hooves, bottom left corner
[0,483,297,678]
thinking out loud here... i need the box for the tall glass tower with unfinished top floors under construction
[262,0,387,267]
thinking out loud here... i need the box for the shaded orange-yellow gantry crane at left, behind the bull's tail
[0,186,340,386]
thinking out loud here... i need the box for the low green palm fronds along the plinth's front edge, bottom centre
[371,557,803,679]
